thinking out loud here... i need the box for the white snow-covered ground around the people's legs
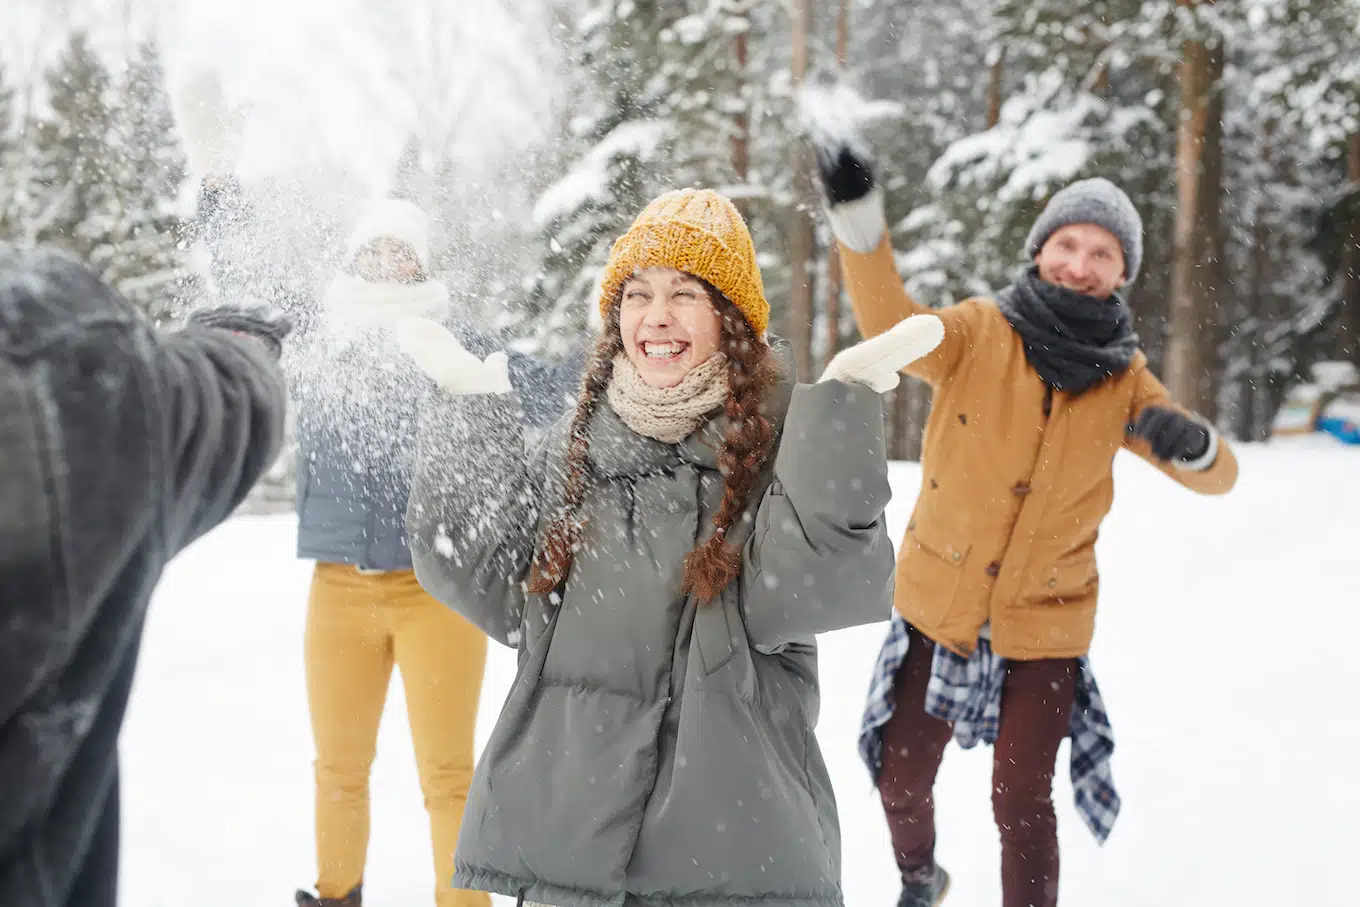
[122,438,1360,907]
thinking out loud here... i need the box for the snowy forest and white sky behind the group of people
[0,0,1360,481]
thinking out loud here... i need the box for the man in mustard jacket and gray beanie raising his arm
[817,140,1238,907]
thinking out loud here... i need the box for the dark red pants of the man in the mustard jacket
[879,627,1077,907]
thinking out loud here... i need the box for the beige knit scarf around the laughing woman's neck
[607,352,728,445]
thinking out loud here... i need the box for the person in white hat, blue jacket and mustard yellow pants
[181,69,585,907]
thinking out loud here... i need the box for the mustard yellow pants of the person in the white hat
[306,563,491,907]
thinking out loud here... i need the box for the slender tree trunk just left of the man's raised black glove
[789,0,815,381]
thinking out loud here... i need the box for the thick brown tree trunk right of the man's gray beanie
[1167,0,1221,413]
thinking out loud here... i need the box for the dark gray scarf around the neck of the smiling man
[997,265,1138,394]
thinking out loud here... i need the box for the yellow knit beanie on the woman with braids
[600,189,770,335]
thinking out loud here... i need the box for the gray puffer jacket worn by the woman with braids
[407,344,894,907]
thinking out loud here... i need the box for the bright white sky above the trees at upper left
[0,0,560,190]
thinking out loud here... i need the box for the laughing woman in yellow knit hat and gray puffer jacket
[401,189,944,907]
